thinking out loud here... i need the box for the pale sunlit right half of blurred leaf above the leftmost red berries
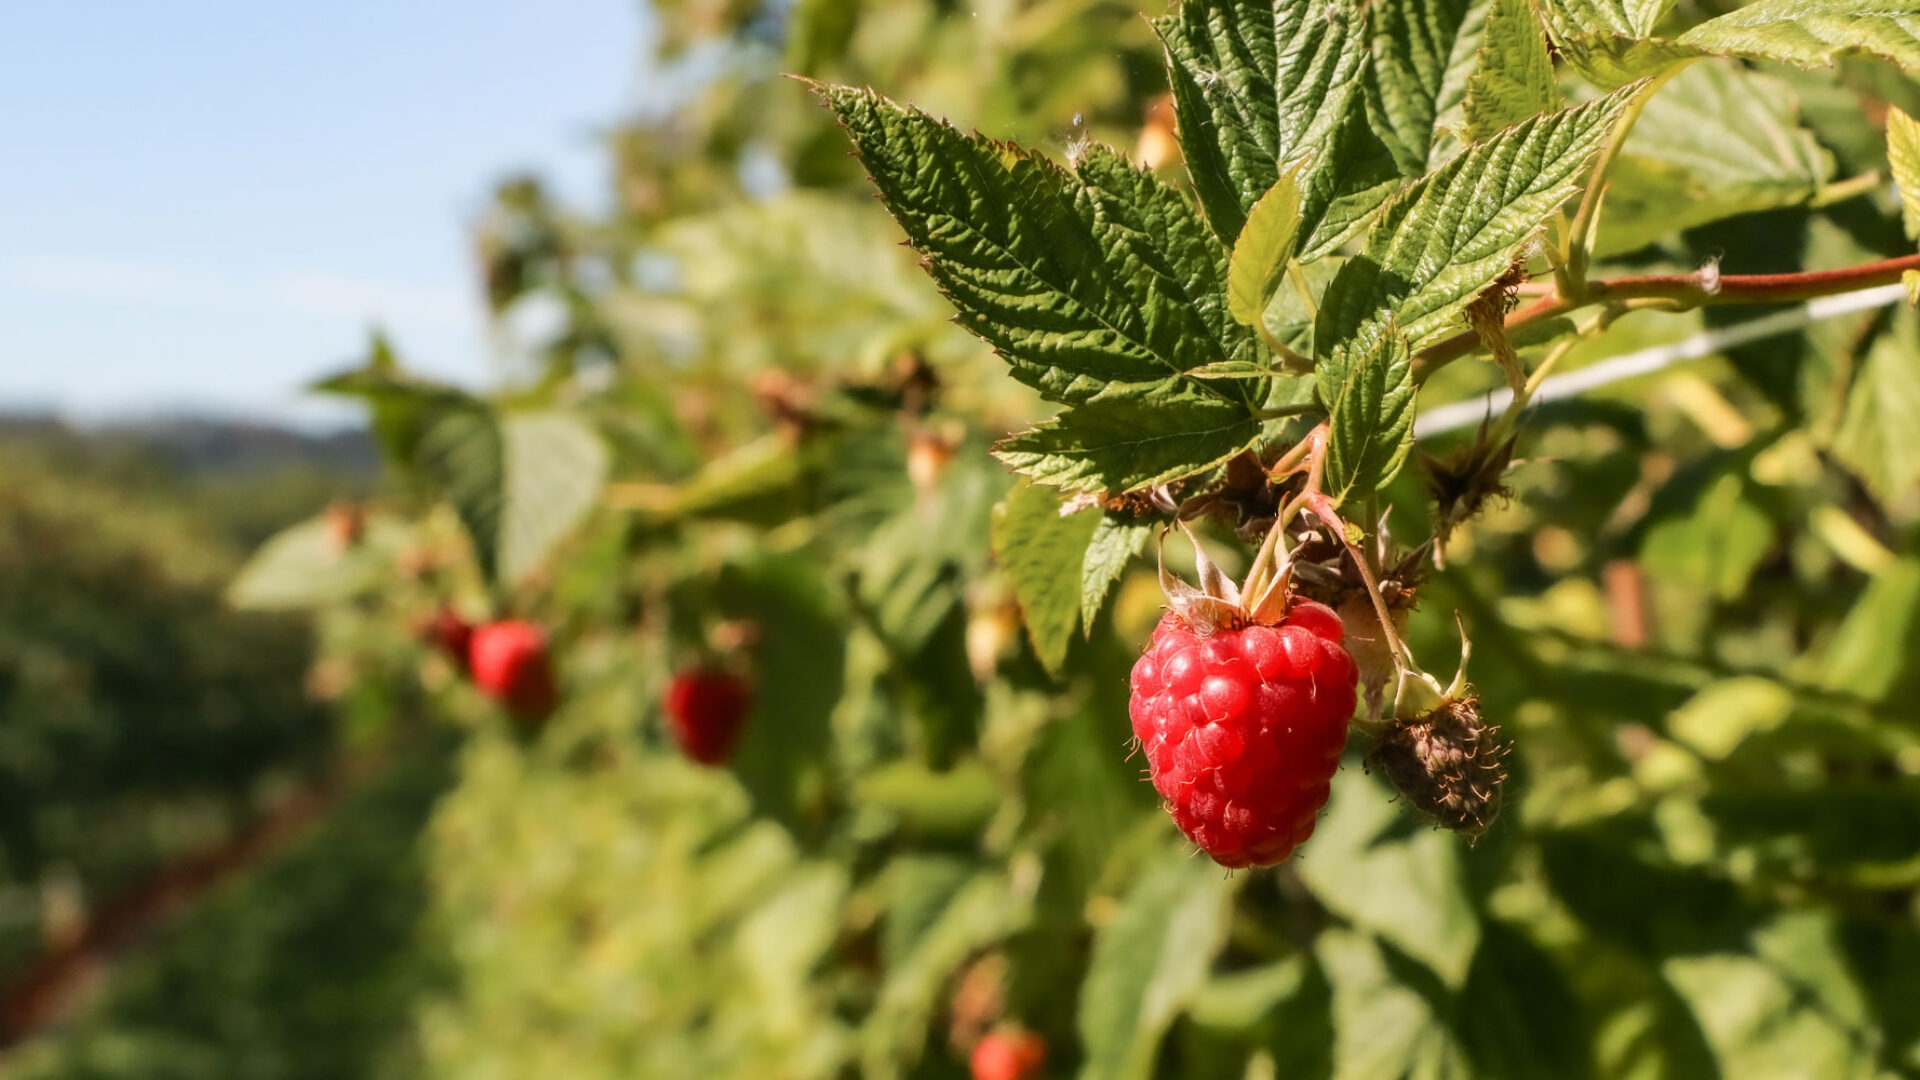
[499,411,607,584]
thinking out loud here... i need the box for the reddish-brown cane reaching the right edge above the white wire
[1413,256,1920,382]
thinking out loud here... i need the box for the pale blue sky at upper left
[0,0,643,423]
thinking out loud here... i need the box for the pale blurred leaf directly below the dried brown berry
[1298,769,1480,988]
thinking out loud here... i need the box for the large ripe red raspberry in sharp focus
[1129,600,1354,867]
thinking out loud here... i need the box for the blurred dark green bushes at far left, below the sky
[0,425,353,970]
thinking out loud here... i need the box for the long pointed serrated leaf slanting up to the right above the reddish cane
[1313,85,1640,356]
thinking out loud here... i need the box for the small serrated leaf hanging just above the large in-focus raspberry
[1321,327,1417,500]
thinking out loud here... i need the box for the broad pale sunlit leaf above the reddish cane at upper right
[1596,60,1834,254]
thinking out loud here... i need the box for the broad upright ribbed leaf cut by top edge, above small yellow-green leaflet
[1154,0,1392,256]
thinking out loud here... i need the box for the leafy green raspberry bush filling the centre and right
[198,0,1920,1080]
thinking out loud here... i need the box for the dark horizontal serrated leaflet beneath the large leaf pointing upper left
[993,380,1260,492]
